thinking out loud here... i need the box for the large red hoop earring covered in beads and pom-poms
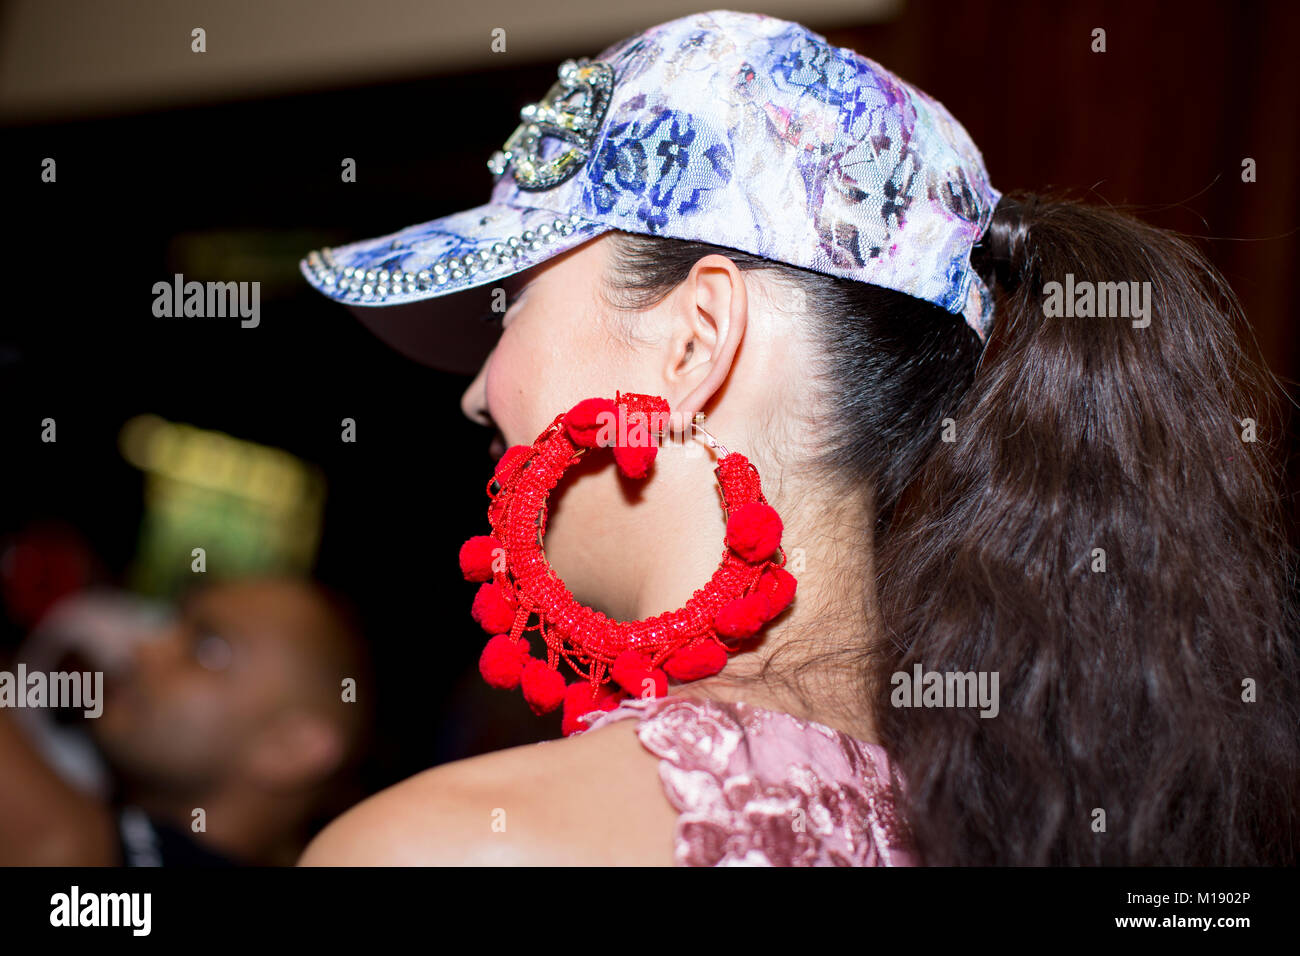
[460,393,796,736]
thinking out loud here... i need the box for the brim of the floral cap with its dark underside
[299,203,610,375]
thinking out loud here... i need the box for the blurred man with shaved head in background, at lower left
[0,578,371,866]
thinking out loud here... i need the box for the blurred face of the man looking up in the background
[88,581,321,790]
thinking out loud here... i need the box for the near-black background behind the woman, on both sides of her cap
[0,0,1300,801]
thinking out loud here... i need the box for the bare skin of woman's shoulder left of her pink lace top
[300,721,676,866]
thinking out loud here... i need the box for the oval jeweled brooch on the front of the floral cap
[488,57,614,190]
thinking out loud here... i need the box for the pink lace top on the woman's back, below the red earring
[588,696,917,866]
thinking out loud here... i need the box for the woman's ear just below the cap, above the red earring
[663,254,749,432]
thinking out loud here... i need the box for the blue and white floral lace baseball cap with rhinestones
[300,10,1001,372]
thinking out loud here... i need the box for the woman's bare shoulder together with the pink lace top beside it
[302,696,914,866]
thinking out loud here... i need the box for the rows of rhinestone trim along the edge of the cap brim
[307,213,582,303]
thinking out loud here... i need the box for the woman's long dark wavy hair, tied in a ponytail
[605,193,1300,865]
